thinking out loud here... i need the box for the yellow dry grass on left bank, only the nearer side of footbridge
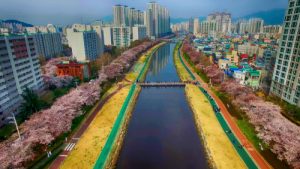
[61,86,130,169]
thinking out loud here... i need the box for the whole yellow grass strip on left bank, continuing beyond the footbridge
[61,43,163,168]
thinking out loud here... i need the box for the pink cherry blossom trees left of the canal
[0,41,159,168]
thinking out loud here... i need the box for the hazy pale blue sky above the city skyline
[0,0,288,24]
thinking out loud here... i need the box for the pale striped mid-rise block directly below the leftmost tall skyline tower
[112,27,131,48]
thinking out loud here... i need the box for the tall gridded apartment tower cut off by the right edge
[271,0,300,106]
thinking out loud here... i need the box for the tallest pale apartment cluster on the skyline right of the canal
[207,12,231,33]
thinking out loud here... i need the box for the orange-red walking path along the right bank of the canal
[178,42,272,169]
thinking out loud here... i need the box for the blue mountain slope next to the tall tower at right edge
[234,9,285,25]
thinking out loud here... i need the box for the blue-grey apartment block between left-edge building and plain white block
[26,25,63,59]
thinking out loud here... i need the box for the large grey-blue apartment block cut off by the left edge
[0,35,43,126]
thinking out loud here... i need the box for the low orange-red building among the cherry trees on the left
[56,61,91,80]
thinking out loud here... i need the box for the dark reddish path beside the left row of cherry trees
[49,85,127,169]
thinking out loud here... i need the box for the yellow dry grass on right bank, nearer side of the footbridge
[185,85,247,169]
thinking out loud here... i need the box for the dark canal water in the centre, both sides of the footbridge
[116,43,209,169]
